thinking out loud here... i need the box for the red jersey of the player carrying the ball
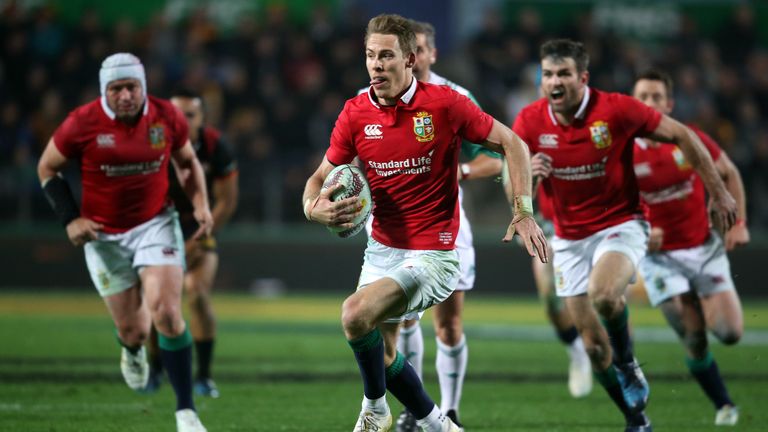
[326,79,493,250]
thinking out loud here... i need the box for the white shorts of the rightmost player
[640,231,736,306]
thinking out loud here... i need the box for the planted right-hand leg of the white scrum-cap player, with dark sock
[139,266,202,429]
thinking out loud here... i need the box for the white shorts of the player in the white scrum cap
[85,208,185,297]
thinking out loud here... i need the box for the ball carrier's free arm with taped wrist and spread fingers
[483,119,549,262]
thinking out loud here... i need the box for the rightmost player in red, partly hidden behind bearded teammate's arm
[633,70,749,426]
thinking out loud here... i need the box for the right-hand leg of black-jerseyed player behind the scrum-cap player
[184,251,219,398]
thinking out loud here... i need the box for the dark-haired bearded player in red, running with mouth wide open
[513,39,736,432]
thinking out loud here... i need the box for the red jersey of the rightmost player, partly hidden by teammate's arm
[634,126,721,250]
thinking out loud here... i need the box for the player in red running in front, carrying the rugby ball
[304,15,547,432]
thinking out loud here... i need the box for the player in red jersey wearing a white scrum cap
[37,53,213,432]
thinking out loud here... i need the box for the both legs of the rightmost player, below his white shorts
[660,291,743,425]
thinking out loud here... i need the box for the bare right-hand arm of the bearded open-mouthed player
[648,115,737,231]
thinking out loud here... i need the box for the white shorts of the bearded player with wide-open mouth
[552,220,650,297]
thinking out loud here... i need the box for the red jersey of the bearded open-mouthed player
[512,88,661,240]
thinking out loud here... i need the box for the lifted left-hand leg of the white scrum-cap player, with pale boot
[104,285,150,391]
